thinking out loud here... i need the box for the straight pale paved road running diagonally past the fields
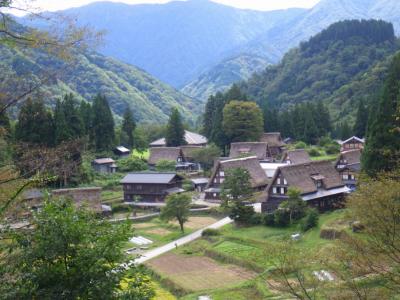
[128,217,233,265]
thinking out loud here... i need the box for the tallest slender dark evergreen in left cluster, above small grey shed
[93,94,115,151]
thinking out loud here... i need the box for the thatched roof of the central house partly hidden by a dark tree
[208,156,268,187]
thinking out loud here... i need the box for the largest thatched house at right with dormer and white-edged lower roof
[262,161,350,212]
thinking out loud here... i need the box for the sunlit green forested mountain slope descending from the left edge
[0,46,202,123]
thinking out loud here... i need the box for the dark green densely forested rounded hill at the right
[240,20,400,122]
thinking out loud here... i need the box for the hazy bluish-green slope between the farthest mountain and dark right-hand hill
[181,54,270,101]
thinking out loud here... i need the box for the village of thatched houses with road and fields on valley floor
[13,127,364,299]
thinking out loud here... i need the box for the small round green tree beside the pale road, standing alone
[160,194,192,233]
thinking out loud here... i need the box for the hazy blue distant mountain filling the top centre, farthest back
[25,0,304,88]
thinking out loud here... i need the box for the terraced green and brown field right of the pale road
[149,211,345,300]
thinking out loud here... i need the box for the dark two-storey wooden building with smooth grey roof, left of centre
[121,172,184,203]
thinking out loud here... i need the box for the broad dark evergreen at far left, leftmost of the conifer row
[15,99,54,146]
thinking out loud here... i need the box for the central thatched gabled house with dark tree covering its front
[205,156,268,201]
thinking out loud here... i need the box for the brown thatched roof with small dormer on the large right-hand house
[268,161,344,195]
